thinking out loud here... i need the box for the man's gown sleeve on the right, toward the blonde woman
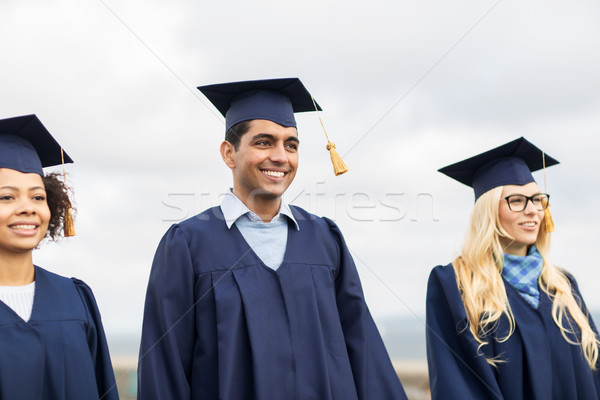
[325,218,407,400]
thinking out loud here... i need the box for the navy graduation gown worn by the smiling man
[138,207,406,400]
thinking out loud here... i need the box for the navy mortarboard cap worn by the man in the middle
[198,78,321,132]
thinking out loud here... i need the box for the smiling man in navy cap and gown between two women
[138,78,406,400]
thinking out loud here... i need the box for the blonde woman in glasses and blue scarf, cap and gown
[427,138,600,400]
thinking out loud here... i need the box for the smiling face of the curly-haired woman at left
[0,168,50,254]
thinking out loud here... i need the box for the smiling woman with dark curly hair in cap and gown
[0,115,118,400]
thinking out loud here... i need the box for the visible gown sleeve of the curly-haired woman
[72,278,119,400]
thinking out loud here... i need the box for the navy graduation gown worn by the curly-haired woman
[0,267,119,400]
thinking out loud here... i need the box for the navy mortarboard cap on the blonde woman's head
[438,137,558,199]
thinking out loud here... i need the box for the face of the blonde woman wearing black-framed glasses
[498,182,544,256]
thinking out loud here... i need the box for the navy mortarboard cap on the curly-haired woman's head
[0,115,73,176]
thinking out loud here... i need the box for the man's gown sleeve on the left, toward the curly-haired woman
[138,225,195,400]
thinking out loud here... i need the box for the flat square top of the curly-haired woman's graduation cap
[0,114,73,173]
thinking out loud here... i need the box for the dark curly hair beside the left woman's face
[42,172,71,240]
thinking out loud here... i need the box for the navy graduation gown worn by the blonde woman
[427,264,600,400]
